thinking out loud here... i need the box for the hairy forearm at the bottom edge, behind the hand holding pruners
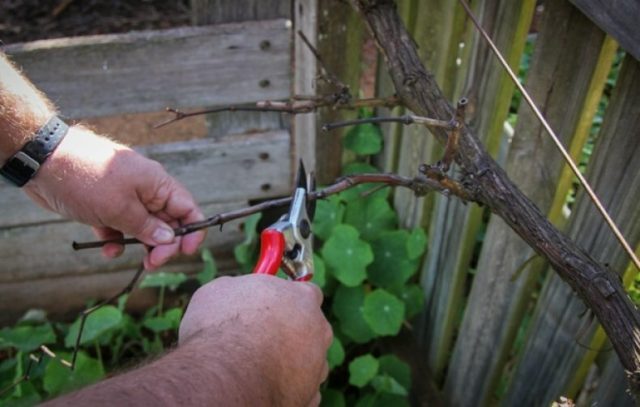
[46,333,277,406]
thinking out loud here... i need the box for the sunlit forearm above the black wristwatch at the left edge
[0,52,55,163]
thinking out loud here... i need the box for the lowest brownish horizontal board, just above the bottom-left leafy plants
[0,253,237,326]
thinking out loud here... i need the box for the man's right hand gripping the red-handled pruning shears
[178,274,333,406]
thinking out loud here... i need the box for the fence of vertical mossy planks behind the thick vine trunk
[370,0,640,406]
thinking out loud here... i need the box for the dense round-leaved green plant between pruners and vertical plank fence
[235,117,427,406]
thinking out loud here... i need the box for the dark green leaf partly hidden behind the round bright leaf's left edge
[333,285,375,343]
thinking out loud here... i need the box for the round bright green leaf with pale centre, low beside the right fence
[362,289,404,335]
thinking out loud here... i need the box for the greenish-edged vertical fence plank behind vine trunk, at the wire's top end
[421,0,535,386]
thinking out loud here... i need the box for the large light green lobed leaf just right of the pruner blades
[321,225,373,287]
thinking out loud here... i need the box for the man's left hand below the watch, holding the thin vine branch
[25,126,205,269]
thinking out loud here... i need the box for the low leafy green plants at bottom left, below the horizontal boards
[0,249,217,406]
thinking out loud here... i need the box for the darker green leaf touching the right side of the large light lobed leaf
[367,230,419,288]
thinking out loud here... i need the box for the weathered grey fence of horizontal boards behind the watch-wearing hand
[0,0,317,323]
